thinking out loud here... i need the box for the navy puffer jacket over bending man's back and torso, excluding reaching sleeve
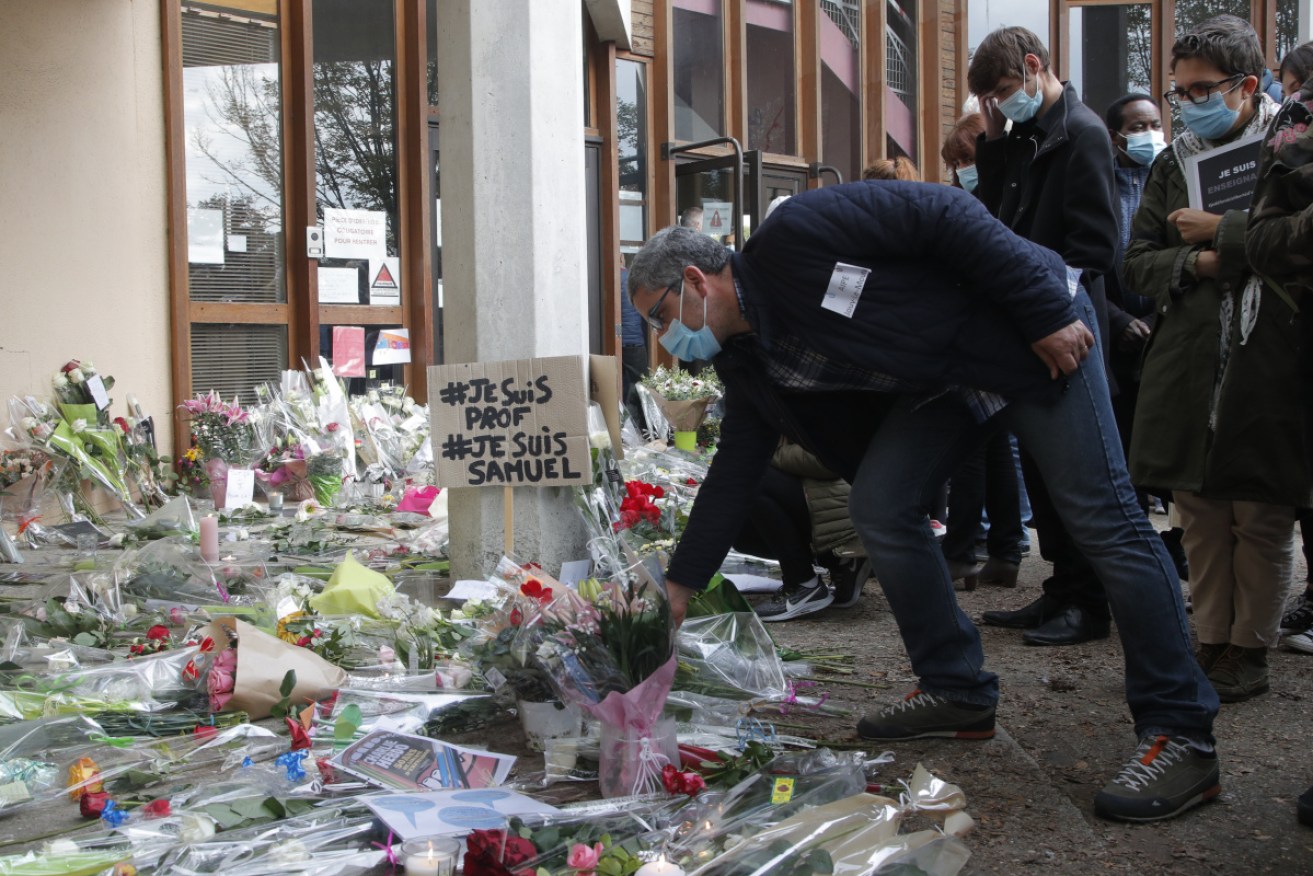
[733,180,1075,398]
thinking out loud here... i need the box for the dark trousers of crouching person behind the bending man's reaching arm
[734,466,815,587]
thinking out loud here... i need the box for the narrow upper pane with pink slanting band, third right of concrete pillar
[819,0,861,181]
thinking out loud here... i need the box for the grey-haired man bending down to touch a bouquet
[629,181,1220,820]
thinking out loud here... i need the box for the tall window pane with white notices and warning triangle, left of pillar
[314,0,404,305]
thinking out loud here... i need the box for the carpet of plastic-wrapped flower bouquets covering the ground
[0,351,969,876]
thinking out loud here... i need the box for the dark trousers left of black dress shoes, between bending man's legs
[943,432,1023,563]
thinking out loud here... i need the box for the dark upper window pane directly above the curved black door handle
[671,0,725,141]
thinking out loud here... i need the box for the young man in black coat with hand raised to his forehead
[966,28,1117,645]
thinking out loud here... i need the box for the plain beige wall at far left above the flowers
[0,0,171,449]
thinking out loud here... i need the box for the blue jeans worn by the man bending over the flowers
[850,292,1218,741]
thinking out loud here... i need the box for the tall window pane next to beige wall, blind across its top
[181,3,286,303]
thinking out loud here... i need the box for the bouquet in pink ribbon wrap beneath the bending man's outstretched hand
[521,566,679,797]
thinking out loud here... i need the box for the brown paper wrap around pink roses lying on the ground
[201,617,347,721]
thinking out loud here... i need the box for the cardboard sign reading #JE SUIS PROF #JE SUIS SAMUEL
[428,356,592,487]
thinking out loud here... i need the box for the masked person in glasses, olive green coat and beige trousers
[1124,22,1313,703]
